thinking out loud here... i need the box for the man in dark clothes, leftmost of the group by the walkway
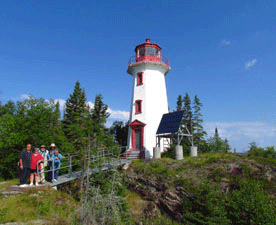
[19,144,32,187]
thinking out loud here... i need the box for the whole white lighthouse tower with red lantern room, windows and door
[127,39,171,158]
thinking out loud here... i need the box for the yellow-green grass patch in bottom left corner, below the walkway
[0,188,78,224]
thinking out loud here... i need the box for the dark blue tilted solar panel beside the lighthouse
[156,110,184,134]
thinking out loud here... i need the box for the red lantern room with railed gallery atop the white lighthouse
[129,38,170,69]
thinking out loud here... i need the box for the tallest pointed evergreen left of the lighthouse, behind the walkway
[63,81,89,152]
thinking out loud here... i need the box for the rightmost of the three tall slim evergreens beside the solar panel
[193,95,207,149]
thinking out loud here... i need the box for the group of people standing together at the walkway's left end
[19,143,63,187]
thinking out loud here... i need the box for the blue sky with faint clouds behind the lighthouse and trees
[0,0,276,151]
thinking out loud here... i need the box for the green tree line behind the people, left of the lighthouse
[0,81,114,179]
